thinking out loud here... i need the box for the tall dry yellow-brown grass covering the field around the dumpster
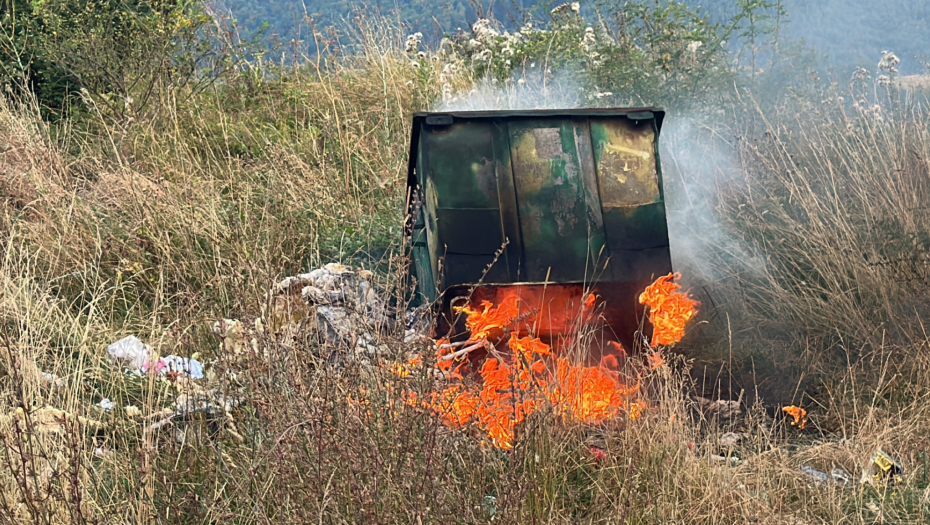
[0,20,930,524]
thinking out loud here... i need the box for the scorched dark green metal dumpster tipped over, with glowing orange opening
[407,108,672,354]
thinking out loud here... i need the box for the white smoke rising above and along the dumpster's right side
[435,72,765,288]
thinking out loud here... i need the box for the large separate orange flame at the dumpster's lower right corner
[639,273,697,346]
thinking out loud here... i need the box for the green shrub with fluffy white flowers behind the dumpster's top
[407,1,732,107]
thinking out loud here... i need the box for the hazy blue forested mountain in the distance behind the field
[215,0,930,74]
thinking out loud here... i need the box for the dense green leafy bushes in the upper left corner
[0,0,248,118]
